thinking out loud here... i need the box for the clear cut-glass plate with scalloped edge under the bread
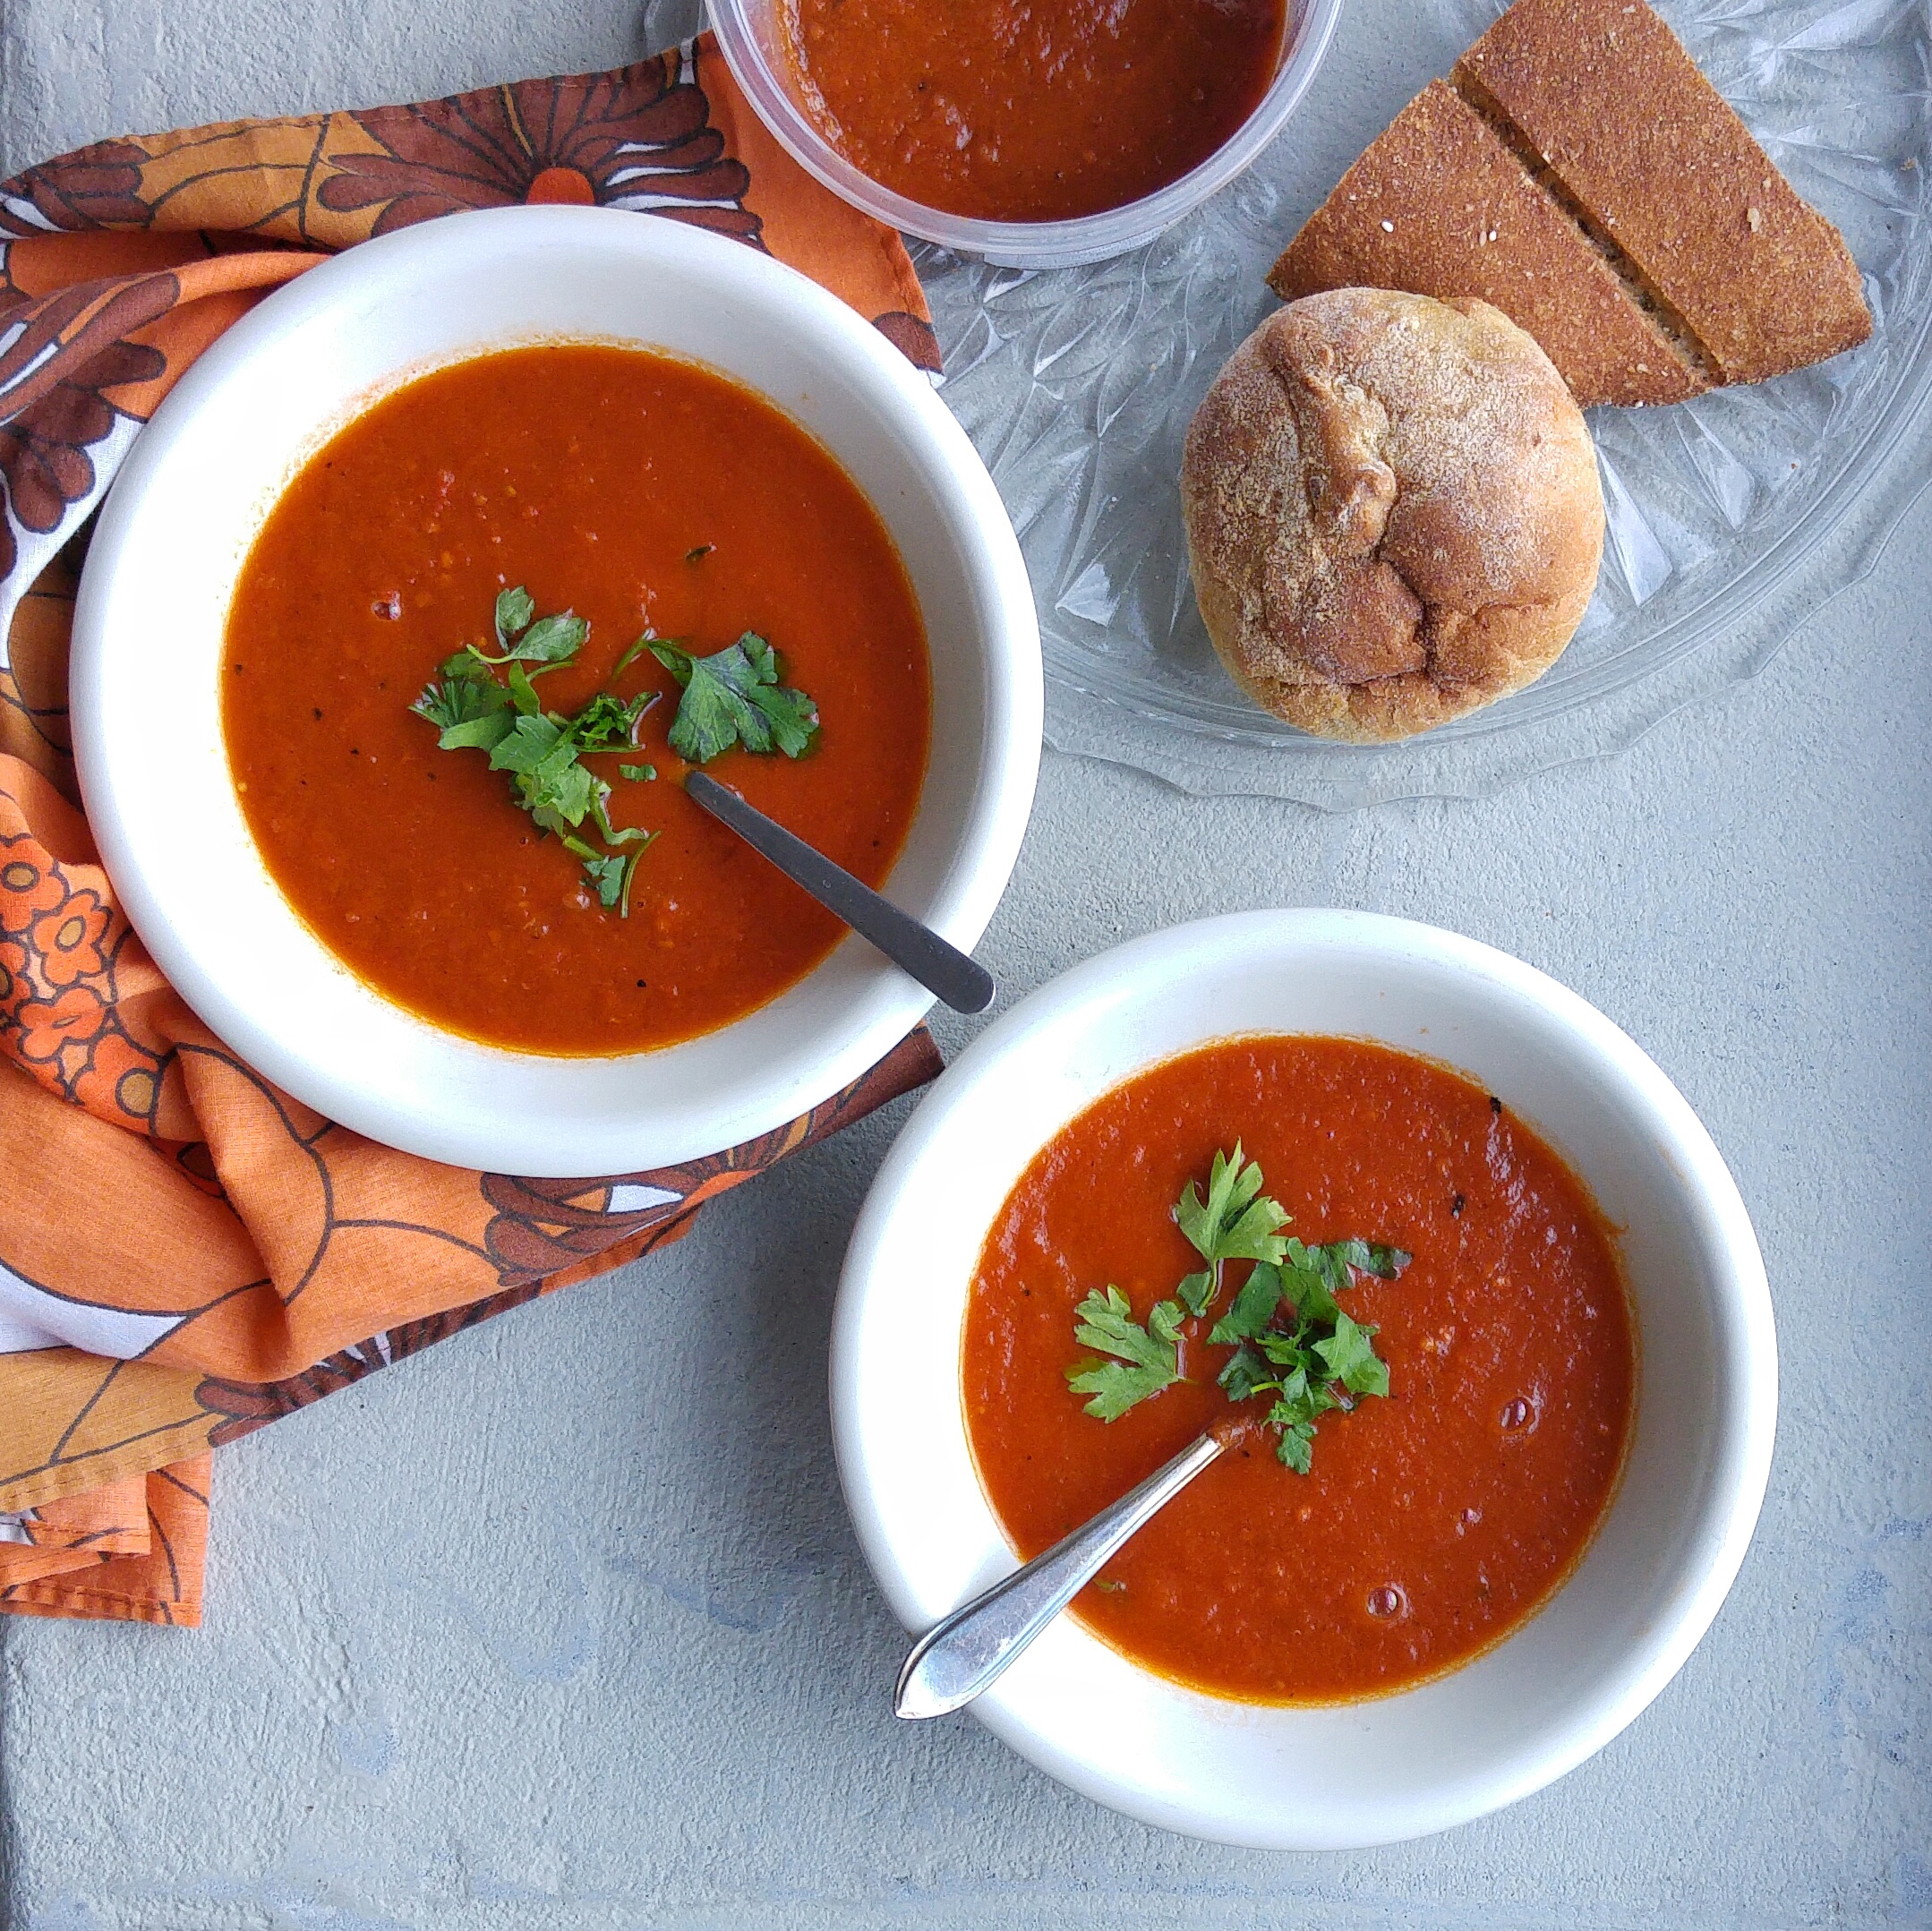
[914,0,1932,807]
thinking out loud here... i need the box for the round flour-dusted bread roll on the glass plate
[1181,287,1603,741]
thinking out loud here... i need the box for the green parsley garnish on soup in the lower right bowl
[1066,1141,1410,1475]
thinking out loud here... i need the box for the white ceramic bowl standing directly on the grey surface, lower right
[831,911,1777,1850]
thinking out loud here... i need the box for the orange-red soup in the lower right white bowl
[964,1037,1635,1703]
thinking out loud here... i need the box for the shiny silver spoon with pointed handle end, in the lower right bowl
[893,1435,1227,1717]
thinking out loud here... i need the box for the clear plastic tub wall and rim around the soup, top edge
[707,0,1341,269]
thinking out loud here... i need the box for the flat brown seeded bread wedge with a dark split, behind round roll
[1269,0,1872,407]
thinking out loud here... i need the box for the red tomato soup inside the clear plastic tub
[779,0,1287,222]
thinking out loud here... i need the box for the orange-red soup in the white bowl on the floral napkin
[222,344,931,1055]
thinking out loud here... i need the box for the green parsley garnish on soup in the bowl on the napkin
[409,583,819,918]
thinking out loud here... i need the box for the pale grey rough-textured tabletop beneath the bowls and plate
[0,0,1932,1931]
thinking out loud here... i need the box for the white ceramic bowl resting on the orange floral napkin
[72,207,1041,1178]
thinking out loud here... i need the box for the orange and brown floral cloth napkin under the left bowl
[0,38,939,1624]
